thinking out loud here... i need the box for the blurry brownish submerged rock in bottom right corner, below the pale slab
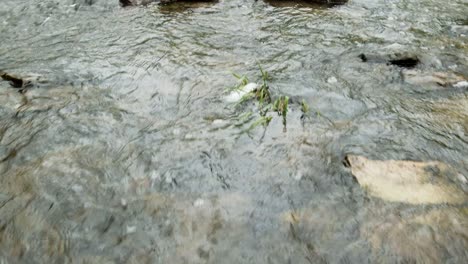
[360,207,468,263]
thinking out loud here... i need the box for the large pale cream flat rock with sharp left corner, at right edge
[346,155,468,204]
